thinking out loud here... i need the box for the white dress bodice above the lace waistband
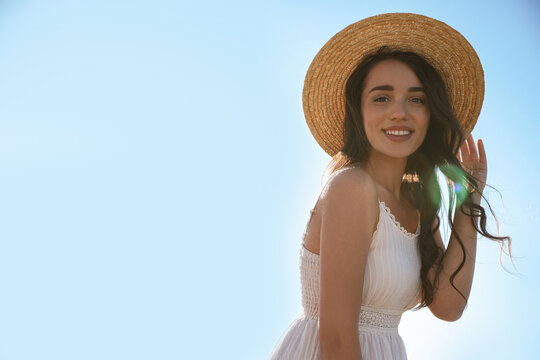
[300,200,422,328]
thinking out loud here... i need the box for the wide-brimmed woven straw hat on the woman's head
[302,13,484,156]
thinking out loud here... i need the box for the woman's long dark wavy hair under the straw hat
[327,47,512,310]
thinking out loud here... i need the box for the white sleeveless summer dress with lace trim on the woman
[270,200,422,360]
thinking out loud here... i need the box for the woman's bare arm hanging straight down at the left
[319,170,378,360]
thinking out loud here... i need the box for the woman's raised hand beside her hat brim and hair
[457,134,487,193]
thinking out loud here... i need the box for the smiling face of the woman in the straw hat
[361,59,430,158]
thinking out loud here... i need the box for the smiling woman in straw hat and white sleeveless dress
[271,13,511,360]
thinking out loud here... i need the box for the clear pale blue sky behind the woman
[0,0,540,360]
